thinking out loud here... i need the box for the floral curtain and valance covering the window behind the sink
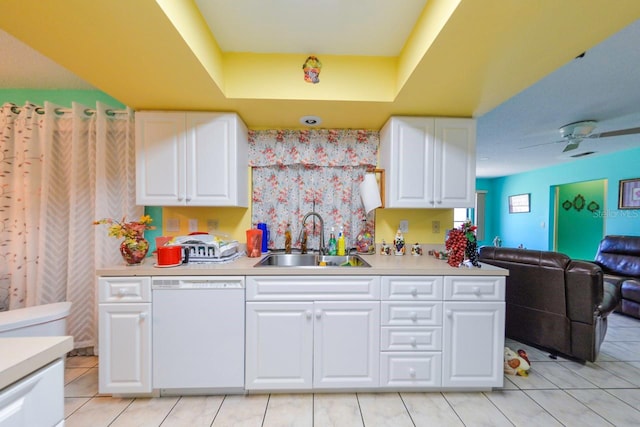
[249,129,380,249]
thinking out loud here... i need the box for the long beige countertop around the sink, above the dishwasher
[96,254,509,276]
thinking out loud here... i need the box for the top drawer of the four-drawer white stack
[382,276,443,301]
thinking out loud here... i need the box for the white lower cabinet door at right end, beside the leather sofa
[442,302,505,388]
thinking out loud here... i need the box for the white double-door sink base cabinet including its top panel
[245,277,380,390]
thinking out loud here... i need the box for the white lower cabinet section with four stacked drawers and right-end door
[380,276,505,389]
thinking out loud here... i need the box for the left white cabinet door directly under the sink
[245,302,313,390]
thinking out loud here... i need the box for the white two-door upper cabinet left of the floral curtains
[136,111,249,207]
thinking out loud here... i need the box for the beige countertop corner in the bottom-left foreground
[0,336,73,390]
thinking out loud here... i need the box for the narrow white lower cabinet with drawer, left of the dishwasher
[98,277,152,394]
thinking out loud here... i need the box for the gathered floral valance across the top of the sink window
[249,129,380,167]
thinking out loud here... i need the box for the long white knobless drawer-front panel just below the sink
[247,276,380,301]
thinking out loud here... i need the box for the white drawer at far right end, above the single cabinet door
[444,276,505,301]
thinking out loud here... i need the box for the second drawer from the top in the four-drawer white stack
[381,301,442,326]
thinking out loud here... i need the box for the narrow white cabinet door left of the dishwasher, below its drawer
[98,303,151,394]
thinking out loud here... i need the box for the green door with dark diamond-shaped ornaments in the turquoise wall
[555,179,607,260]
